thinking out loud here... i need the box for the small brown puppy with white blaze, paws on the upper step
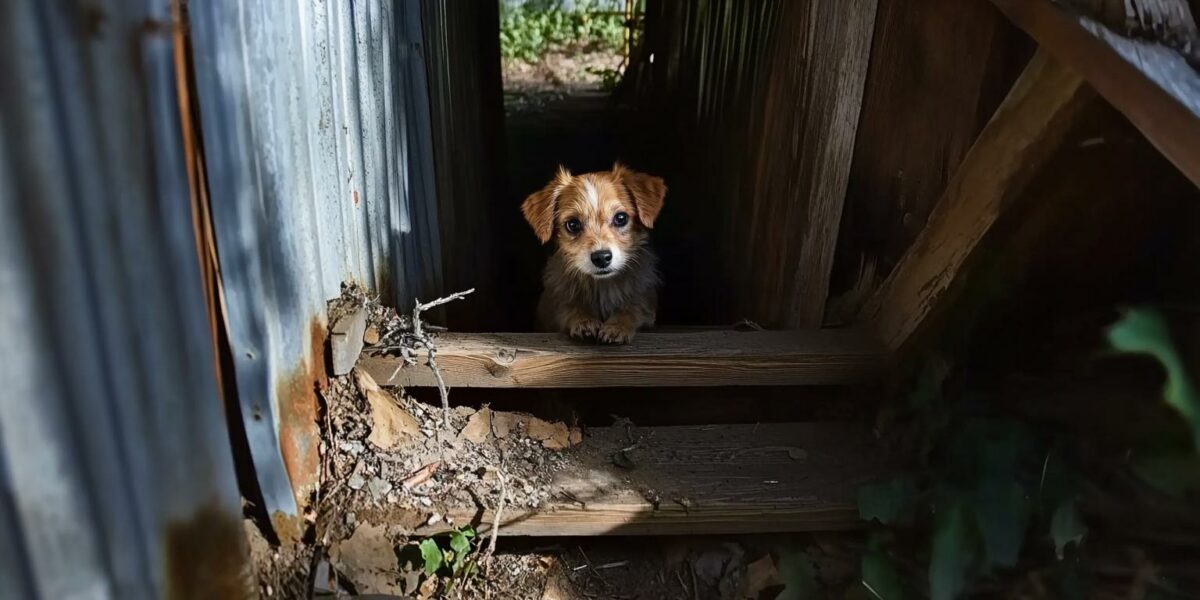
[521,163,667,343]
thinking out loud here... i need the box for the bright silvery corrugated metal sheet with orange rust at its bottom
[190,0,442,515]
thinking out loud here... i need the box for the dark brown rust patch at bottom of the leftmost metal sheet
[164,504,258,600]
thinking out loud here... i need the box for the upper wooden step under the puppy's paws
[359,330,887,388]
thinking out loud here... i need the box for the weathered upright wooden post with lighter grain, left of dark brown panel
[757,0,876,329]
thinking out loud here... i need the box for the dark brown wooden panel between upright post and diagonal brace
[826,0,1036,324]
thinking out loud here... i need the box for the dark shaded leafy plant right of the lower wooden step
[858,361,1087,600]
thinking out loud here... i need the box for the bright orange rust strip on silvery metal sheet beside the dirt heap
[275,318,328,506]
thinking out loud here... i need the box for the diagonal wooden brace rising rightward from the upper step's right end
[859,52,1091,349]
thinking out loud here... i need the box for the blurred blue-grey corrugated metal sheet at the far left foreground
[0,0,244,599]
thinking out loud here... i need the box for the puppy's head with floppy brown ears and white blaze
[521,164,667,280]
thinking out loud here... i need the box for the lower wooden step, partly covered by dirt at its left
[419,424,888,536]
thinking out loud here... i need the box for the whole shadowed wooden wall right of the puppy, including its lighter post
[620,0,877,328]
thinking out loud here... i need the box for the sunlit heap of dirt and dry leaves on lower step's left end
[323,370,582,535]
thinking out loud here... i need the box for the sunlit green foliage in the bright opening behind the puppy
[500,0,625,62]
